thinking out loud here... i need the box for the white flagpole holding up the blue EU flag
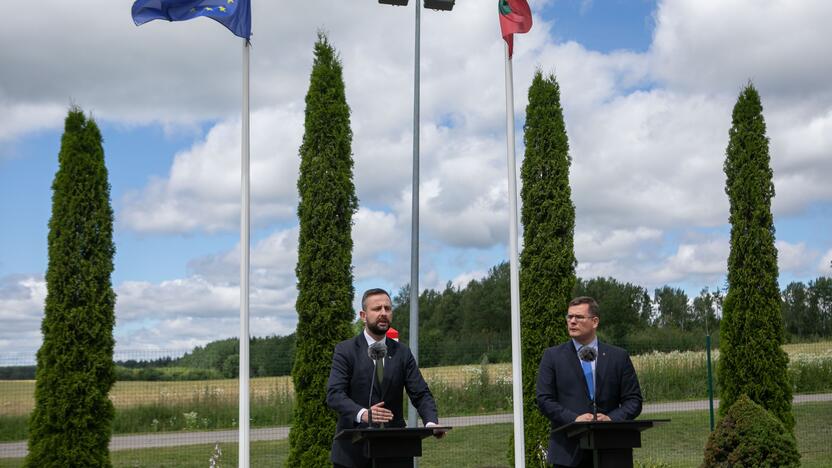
[237,39,251,468]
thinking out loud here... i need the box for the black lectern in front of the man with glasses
[553,419,670,468]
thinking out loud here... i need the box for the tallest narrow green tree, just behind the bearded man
[288,33,358,468]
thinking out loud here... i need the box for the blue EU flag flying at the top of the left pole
[132,0,251,39]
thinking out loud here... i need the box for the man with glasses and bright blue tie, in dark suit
[537,297,642,467]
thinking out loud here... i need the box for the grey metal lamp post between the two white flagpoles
[378,0,455,436]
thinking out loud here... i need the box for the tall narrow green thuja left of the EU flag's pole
[26,107,115,467]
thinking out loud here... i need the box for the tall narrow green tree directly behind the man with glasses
[520,70,576,466]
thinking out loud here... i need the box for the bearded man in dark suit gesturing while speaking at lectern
[326,289,444,468]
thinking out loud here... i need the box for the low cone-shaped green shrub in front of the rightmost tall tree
[702,395,800,468]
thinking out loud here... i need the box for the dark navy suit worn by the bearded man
[326,332,439,467]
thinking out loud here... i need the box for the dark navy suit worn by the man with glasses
[537,340,642,466]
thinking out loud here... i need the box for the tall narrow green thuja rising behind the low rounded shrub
[718,83,794,430]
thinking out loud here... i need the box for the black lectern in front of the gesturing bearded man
[335,426,451,468]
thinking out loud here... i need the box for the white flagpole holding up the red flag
[505,43,526,467]
